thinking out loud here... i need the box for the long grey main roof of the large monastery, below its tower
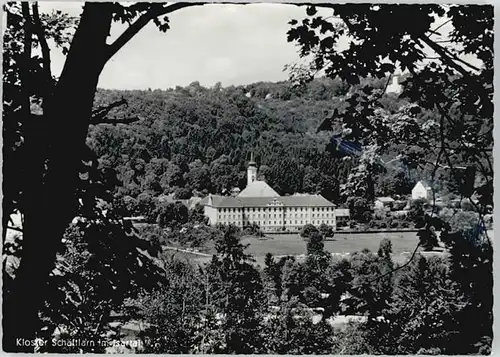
[202,195,334,208]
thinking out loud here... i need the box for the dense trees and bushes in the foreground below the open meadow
[130,222,492,354]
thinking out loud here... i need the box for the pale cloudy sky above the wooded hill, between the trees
[39,1,332,89]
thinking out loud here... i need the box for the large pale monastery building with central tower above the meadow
[201,155,349,232]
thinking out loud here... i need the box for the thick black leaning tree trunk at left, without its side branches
[3,3,112,352]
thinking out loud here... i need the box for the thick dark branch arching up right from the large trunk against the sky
[107,2,205,59]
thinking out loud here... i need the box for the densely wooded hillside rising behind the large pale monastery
[88,79,418,203]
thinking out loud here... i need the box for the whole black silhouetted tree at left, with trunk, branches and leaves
[4,3,205,351]
